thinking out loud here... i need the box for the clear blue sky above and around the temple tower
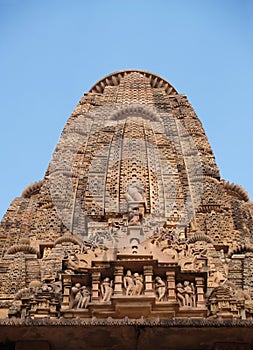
[0,0,253,217]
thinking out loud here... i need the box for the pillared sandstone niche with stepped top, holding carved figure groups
[60,249,207,318]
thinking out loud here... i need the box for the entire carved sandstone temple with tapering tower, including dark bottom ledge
[0,70,253,350]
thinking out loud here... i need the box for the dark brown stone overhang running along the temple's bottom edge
[0,318,253,350]
